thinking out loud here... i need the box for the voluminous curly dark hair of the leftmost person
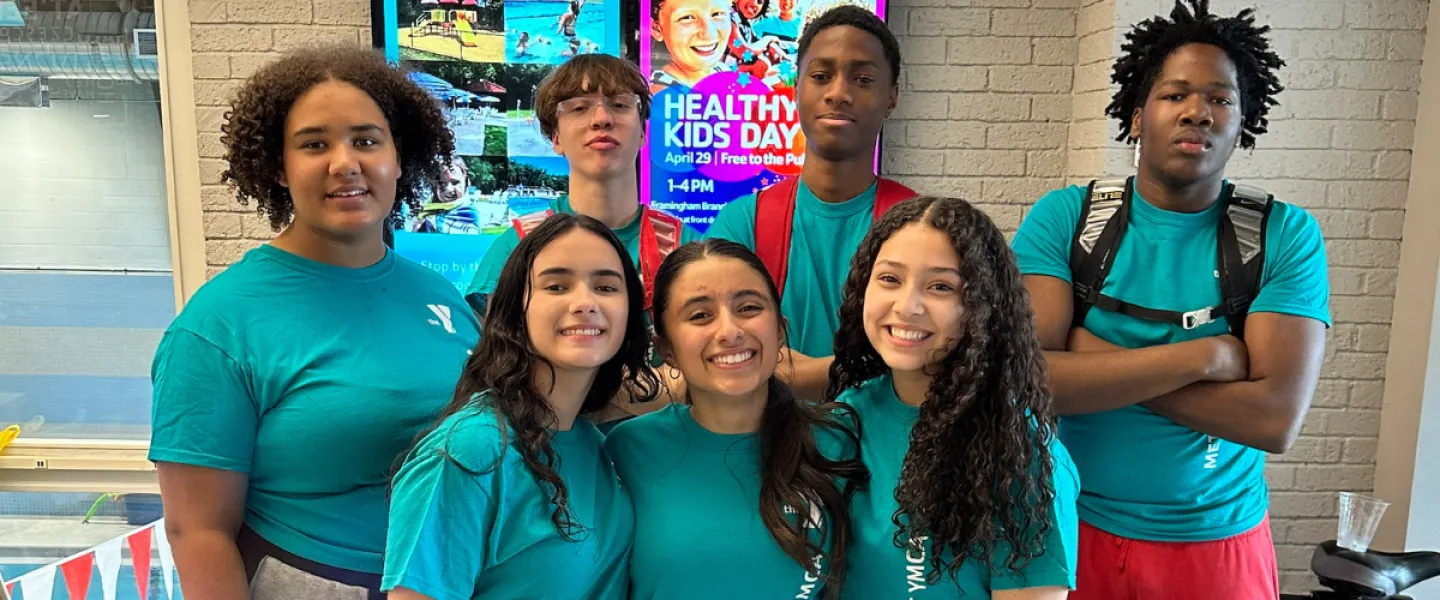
[220,45,455,232]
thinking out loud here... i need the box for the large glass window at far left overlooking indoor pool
[0,0,177,592]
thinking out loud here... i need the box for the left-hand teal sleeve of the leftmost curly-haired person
[150,328,261,473]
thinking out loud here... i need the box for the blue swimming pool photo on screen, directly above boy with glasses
[505,0,619,65]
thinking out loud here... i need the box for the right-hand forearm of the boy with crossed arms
[1145,381,1309,453]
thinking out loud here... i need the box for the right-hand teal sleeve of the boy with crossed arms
[1250,204,1332,327]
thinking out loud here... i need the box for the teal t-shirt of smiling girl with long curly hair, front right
[840,374,1080,592]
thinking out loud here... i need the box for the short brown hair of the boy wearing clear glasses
[534,55,649,141]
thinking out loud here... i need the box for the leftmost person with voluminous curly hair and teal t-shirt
[150,46,480,600]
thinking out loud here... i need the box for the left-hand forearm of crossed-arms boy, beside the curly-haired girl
[1045,342,1208,414]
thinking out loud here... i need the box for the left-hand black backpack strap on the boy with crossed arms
[1070,177,1133,327]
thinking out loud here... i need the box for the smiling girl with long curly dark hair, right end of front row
[825,197,1080,600]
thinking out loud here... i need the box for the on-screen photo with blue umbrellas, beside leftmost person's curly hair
[402,60,508,157]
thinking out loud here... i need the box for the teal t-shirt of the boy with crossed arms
[1014,179,1331,541]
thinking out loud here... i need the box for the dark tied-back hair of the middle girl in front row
[651,237,870,599]
